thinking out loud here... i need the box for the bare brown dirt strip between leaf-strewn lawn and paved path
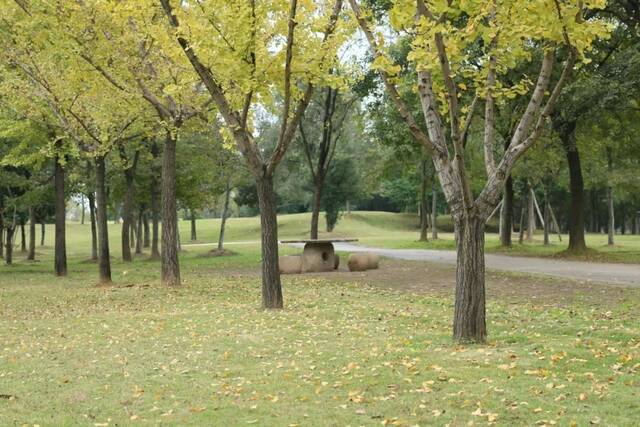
[284,259,640,305]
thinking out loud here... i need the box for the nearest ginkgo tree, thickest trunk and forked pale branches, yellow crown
[349,0,608,342]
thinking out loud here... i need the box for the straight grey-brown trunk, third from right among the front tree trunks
[161,132,180,286]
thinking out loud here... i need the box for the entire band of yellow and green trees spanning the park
[0,0,638,341]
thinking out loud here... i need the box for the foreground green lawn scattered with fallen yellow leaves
[0,239,640,426]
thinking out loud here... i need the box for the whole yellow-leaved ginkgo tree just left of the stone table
[157,0,352,308]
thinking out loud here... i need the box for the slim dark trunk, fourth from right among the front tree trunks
[95,157,111,284]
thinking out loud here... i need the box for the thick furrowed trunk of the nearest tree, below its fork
[453,216,487,343]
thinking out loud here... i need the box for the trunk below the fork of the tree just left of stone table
[256,176,283,308]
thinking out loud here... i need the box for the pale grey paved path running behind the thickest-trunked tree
[298,243,640,287]
